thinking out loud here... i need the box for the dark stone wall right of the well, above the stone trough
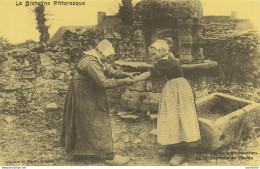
[204,32,260,86]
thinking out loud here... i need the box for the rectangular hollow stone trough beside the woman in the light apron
[196,93,260,150]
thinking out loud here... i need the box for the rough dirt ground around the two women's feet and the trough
[0,82,260,166]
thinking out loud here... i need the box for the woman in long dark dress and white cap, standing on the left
[61,40,133,165]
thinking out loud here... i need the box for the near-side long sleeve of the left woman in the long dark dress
[87,62,119,88]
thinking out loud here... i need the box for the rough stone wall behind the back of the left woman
[0,48,75,114]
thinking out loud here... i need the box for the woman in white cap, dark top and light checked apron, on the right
[134,40,200,165]
